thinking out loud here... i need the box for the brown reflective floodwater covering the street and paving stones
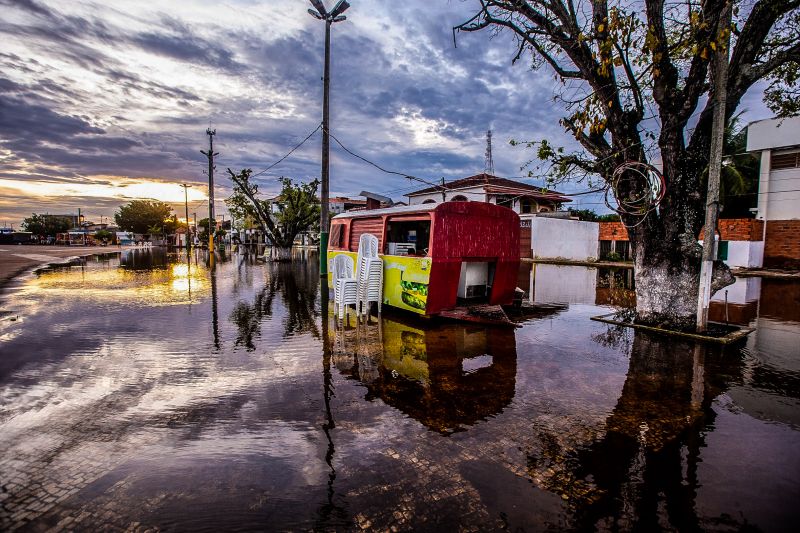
[0,250,800,531]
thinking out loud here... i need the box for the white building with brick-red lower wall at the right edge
[747,117,800,268]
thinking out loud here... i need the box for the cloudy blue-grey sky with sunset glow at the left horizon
[0,0,769,225]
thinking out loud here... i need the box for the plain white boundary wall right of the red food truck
[531,217,600,261]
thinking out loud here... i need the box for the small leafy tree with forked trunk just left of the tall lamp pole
[225,168,319,261]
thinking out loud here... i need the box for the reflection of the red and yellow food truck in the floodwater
[329,315,517,435]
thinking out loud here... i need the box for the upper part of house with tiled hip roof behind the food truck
[406,170,572,214]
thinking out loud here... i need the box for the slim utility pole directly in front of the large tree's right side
[697,2,731,332]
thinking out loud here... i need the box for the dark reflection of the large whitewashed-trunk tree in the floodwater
[528,331,752,531]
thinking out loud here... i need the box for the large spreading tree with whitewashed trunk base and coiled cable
[457,0,800,329]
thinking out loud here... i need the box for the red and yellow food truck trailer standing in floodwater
[328,198,519,316]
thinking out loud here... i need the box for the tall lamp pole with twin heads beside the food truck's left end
[308,0,350,276]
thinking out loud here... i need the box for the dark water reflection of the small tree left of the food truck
[230,261,320,350]
